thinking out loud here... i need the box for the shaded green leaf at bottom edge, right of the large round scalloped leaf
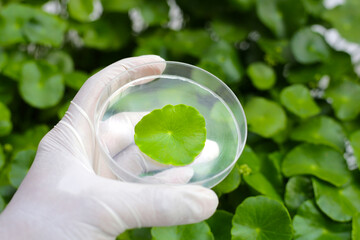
[293,200,351,240]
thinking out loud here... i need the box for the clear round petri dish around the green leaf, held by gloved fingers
[95,61,247,187]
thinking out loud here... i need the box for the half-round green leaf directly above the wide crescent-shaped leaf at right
[290,116,345,152]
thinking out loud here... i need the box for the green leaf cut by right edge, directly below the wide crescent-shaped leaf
[313,172,360,222]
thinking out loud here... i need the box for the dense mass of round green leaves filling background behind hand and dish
[0,0,360,240]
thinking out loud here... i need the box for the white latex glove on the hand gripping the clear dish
[0,56,218,240]
